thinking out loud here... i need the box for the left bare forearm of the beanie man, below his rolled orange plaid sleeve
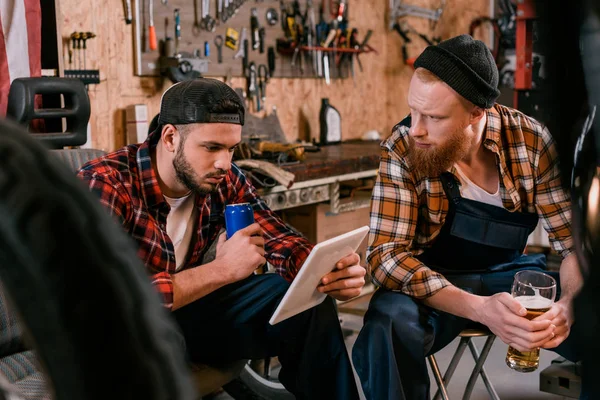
[423,285,483,321]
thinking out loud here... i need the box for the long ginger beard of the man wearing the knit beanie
[407,128,470,177]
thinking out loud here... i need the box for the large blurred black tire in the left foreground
[0,121,196,400]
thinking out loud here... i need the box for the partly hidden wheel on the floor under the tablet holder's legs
[223,358,296,400]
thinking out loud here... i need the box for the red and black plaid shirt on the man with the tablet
[78,135,313,308]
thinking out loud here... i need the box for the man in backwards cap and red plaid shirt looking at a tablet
[79,78,365,399]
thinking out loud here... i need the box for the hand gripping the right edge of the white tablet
[317,253,366,300]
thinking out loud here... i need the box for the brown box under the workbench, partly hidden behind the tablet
[283,203,370,265]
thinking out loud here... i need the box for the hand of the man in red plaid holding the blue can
[215,223,266,283]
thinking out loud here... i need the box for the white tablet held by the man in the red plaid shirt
[269,226,369,325]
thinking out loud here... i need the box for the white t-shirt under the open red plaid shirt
[163,193,196,271]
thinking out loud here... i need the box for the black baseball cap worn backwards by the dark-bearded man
[158,78,244,126]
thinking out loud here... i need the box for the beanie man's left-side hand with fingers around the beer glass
[477,293,557,351]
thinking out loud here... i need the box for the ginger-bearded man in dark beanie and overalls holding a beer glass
[353,35,581,400]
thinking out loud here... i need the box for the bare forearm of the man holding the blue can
[172,260,230,310]
